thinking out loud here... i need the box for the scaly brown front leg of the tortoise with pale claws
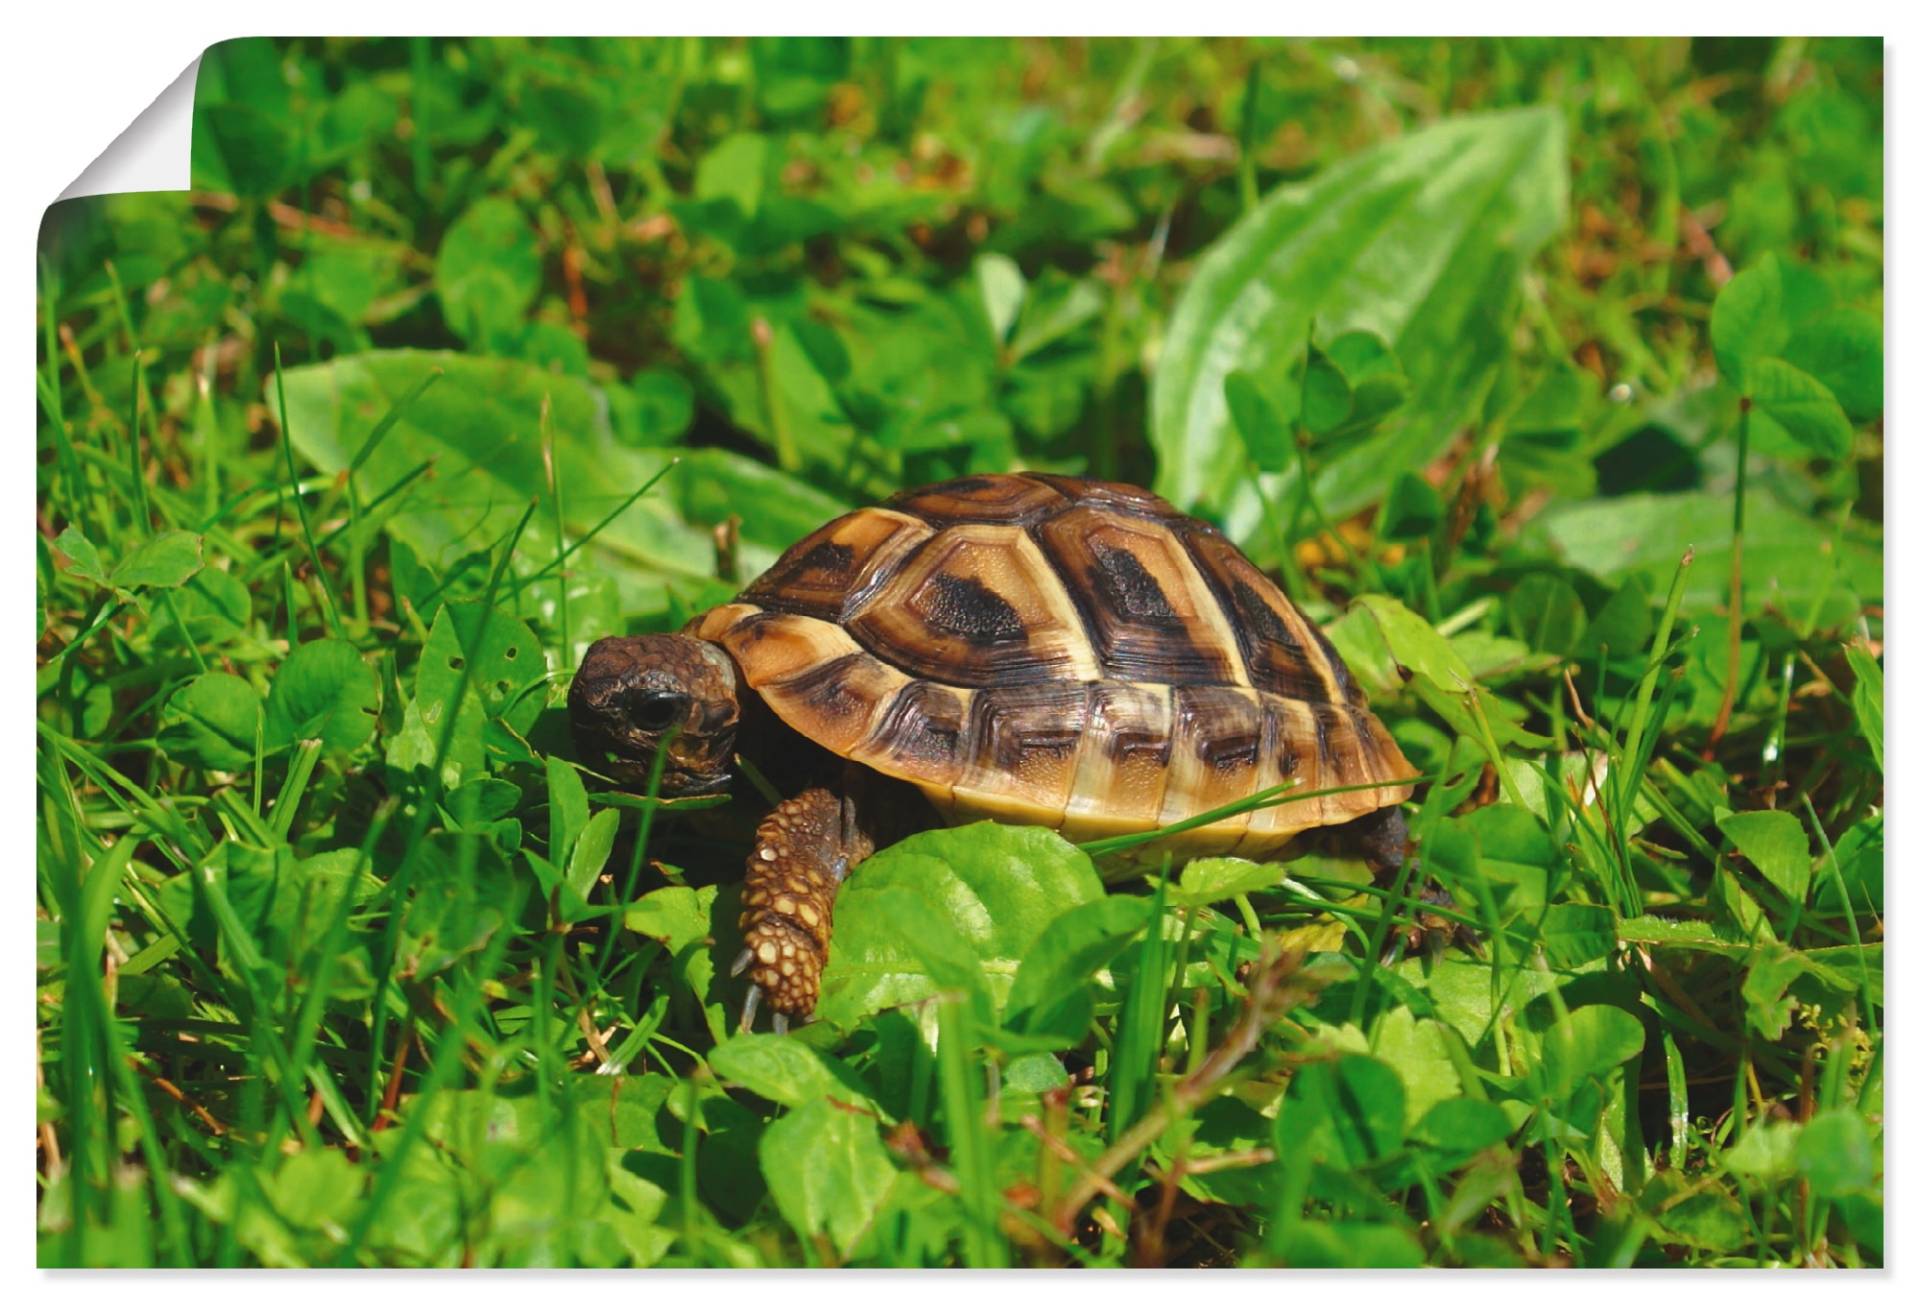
[733,789,874,1032]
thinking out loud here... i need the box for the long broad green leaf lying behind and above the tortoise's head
[274,349,845,610]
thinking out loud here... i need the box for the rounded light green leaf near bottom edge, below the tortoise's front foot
[760,1100,899,1257]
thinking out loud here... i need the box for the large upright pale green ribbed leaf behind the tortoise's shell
[1150,109,1567,525]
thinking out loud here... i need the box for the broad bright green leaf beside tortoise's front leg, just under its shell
[818,821,1104,1025]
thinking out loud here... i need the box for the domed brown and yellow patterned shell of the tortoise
[687,474,1415,858]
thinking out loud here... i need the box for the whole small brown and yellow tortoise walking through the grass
[568,474,1413,1027]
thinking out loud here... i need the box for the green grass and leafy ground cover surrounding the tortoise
[35,38,1885,1267]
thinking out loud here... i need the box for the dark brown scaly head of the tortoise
[566,635,739,796]
